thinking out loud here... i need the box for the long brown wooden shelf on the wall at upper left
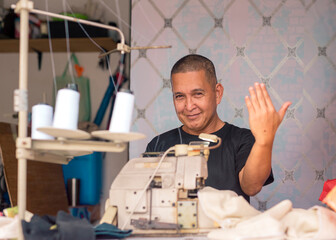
[0,38,117,53]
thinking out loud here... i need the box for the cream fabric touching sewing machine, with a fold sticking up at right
[198,187,292,240]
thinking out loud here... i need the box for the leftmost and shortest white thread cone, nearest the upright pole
[31,103,54,140]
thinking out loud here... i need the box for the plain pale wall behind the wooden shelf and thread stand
[0,0,130,215]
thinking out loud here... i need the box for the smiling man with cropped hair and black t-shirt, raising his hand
[146,54,291,201]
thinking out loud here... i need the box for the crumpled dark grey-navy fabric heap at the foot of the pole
[21,211,95,240]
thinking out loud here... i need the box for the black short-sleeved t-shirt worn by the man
[146,123,274,201]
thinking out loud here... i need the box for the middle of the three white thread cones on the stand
[53,85,80,130]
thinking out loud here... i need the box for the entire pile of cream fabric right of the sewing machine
[198,187,336,240]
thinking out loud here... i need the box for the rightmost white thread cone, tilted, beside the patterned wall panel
[109,89,134,133]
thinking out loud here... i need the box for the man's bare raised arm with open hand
[239,83,291,196]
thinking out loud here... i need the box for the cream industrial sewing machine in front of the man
[101,134,221,233]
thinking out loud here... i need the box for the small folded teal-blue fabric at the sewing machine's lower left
[94,223,132,239]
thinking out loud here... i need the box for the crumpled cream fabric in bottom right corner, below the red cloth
[282,206,336,239]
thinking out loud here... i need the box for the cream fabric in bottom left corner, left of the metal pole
[0,216,20,239]
